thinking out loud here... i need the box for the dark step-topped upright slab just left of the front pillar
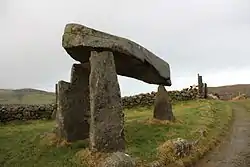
[56,64,90,141]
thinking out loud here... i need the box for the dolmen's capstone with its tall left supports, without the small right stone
[56,24,171,152]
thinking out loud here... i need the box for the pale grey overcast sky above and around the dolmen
[0,0,250,96]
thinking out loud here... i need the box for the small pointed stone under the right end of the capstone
[154,85,174,120]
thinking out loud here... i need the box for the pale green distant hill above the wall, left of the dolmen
[0,88,55,104]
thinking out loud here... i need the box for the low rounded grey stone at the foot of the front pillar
[98,152,136,167]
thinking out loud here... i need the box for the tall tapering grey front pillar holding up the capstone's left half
[89,51,125,152]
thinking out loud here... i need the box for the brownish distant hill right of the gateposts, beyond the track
[208,84,250,100]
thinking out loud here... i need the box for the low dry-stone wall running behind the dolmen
[0,87,198,122]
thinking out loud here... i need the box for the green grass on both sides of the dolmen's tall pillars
[0,101,232,167]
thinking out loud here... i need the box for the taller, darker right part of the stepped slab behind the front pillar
[70,64,90,140]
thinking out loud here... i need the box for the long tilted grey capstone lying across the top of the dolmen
[62,24,171,86]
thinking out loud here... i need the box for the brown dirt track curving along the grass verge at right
[194,104,250,167]
